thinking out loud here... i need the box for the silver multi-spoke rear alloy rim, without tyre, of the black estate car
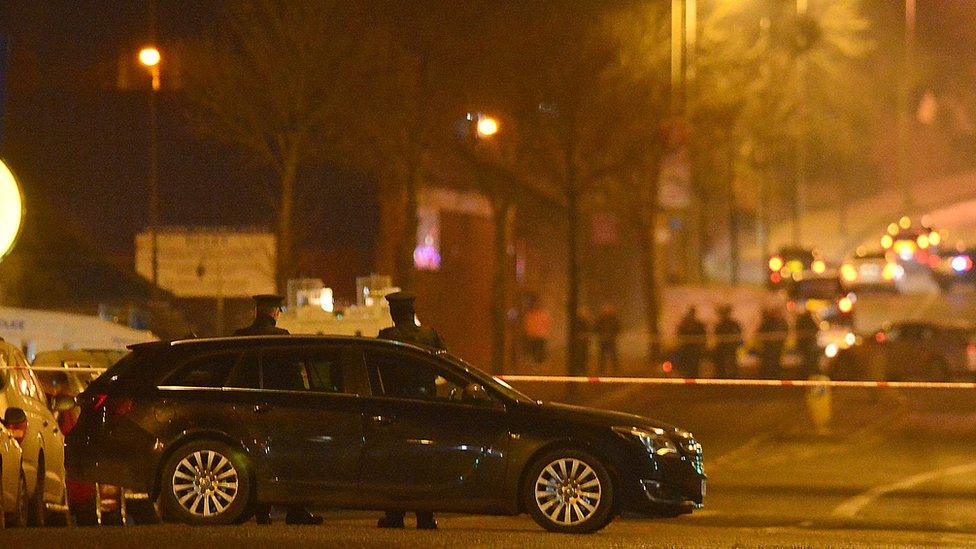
[172,450,240,517]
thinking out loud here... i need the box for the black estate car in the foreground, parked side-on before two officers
[67,336,705,532]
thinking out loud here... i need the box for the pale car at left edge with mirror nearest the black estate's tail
[0,340,73,526]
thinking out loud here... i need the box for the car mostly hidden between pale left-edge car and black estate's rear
[32,349,159,526]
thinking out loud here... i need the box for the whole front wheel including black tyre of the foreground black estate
[523,449,614,534]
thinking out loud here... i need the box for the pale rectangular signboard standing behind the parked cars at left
[136,228,276,298]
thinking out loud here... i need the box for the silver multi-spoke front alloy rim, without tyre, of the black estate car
[535,458,601,526]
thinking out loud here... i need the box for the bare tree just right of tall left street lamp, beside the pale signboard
[181,0,368,290]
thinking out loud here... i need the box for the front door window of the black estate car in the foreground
[366,349,466,402]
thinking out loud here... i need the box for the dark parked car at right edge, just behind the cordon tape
[830,322,976,381]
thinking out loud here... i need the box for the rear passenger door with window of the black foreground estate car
[242,344,369,501]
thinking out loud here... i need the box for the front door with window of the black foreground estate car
[360,346,508,510]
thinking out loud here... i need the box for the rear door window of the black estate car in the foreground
[261,348,347,393]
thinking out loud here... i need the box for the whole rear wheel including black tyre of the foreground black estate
[159,440,251,525]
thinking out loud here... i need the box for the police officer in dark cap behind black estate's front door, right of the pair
[377,292,446,530]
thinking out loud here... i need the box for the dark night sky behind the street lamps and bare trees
[0,0,976,255]
